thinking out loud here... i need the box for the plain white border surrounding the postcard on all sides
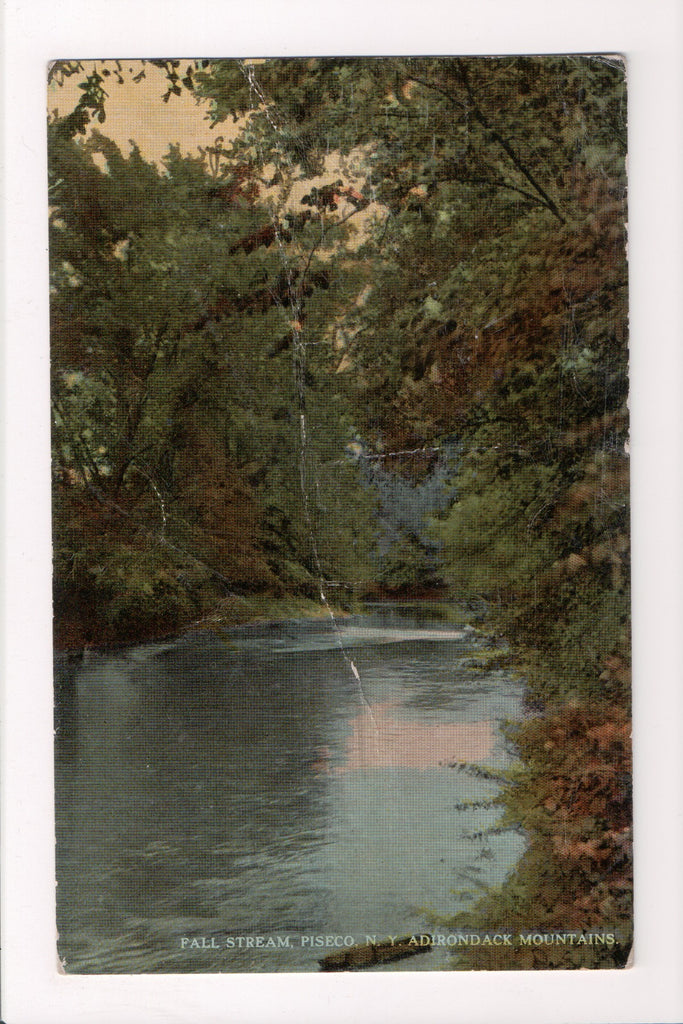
[1,0,683,1024]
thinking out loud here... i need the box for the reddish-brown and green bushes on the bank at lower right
[447,643,633,971]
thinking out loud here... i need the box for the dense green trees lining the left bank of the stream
[50,121,372,639]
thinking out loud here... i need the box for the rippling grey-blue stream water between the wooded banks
[56,607,523,974]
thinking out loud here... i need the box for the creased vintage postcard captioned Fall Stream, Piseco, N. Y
[47,52,633,976]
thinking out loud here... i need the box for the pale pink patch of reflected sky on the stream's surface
[312,703,496,772]
